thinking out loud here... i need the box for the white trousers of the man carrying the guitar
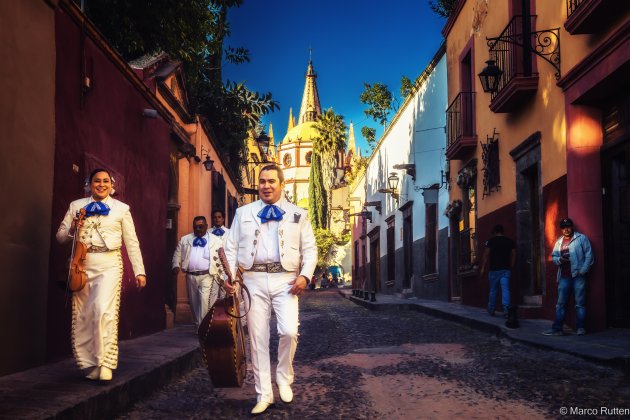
[243,271,299,403]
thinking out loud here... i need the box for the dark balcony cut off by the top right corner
[564,0,630,35]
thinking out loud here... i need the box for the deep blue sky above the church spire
[223,0,445,155]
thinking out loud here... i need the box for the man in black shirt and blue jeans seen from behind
[481,225,516,318]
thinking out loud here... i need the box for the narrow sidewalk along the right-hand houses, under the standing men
[339,289,630,374]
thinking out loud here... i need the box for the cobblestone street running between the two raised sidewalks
[119,291,630,419]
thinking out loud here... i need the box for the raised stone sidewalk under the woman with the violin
[0,325,202,419]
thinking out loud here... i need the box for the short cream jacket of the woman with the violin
[57,197,146,276]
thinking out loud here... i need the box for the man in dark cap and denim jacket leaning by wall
[543,218,595,336]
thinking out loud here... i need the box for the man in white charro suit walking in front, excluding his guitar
[225,164,317,414]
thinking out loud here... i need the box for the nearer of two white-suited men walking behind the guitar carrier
[172,216,223,328]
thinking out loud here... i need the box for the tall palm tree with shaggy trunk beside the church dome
[313,108,348,225]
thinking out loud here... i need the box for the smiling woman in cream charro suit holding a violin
[57,169,147,381]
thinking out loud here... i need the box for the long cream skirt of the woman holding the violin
[72,250,123,369]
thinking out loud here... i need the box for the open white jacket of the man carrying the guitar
[225,200,317,279]
